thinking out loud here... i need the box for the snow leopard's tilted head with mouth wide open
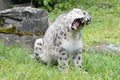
[68,8,91,30]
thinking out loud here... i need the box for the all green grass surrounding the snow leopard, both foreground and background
[0,0,120,80]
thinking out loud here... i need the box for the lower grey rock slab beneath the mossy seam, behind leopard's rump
[0,33,39,51]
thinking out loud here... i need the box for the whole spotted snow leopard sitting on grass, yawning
[34,8,91,69]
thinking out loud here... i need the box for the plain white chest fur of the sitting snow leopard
[62,32,82,53]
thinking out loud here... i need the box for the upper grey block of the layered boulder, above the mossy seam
[0,7,48,34]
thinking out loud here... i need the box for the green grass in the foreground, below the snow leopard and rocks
[0,43,120,80]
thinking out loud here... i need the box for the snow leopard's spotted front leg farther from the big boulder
[73,49,82,68]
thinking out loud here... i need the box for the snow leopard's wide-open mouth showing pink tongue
[71,18,86,30]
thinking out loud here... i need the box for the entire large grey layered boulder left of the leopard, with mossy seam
[0,7,48,50]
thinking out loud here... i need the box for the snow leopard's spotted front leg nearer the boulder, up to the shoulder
[54,31,69,69]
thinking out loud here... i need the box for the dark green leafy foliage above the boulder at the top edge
[36,0,73,11]
